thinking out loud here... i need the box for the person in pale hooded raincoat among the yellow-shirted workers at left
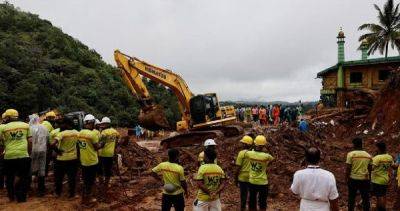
[29,114,49,197]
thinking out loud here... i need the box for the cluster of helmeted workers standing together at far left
[0,109,120,206]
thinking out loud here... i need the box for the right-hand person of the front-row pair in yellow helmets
[247,135,274,210]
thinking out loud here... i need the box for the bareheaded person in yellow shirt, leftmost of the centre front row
[152,149,188,211]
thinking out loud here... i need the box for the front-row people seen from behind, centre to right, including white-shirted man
[152,135,400,211]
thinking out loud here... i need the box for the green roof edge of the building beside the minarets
[317,56,400,78]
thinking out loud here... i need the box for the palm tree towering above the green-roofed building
[358,0,400,58]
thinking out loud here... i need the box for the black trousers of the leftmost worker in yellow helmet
[4,157,31,202]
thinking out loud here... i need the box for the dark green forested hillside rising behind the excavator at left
[0,3,179,126]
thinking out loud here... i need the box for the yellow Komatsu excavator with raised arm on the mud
[114,50,243,148]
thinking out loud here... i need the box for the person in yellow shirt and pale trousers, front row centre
[193,148,226,211]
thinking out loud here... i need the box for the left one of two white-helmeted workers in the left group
[78,114,104,205]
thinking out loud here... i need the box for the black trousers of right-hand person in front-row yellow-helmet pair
[249,184,268,210]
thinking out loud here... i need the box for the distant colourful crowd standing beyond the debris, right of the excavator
[236,104,304,126]
